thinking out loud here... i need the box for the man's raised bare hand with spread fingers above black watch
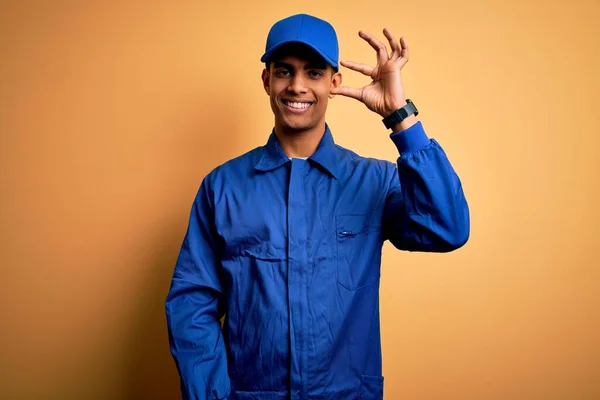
[331,28,408,118]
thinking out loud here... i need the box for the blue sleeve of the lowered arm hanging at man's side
[166,179,230,400]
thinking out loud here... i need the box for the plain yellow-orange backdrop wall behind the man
[0,0,600,400]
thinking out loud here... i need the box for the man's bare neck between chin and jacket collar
[275,121,325,158]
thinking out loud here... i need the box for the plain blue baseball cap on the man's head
[260,14,339,70]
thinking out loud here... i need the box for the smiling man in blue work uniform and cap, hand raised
[166,14,469,400]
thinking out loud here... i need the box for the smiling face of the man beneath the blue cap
[262,47,342,133]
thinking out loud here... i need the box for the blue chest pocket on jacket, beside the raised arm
[335,214,382,290]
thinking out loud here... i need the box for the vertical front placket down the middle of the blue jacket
[287,159,308,400]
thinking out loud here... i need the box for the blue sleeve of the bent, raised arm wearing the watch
[383,121,470,252]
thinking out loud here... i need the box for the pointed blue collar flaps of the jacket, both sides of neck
[255,124,339,179]
